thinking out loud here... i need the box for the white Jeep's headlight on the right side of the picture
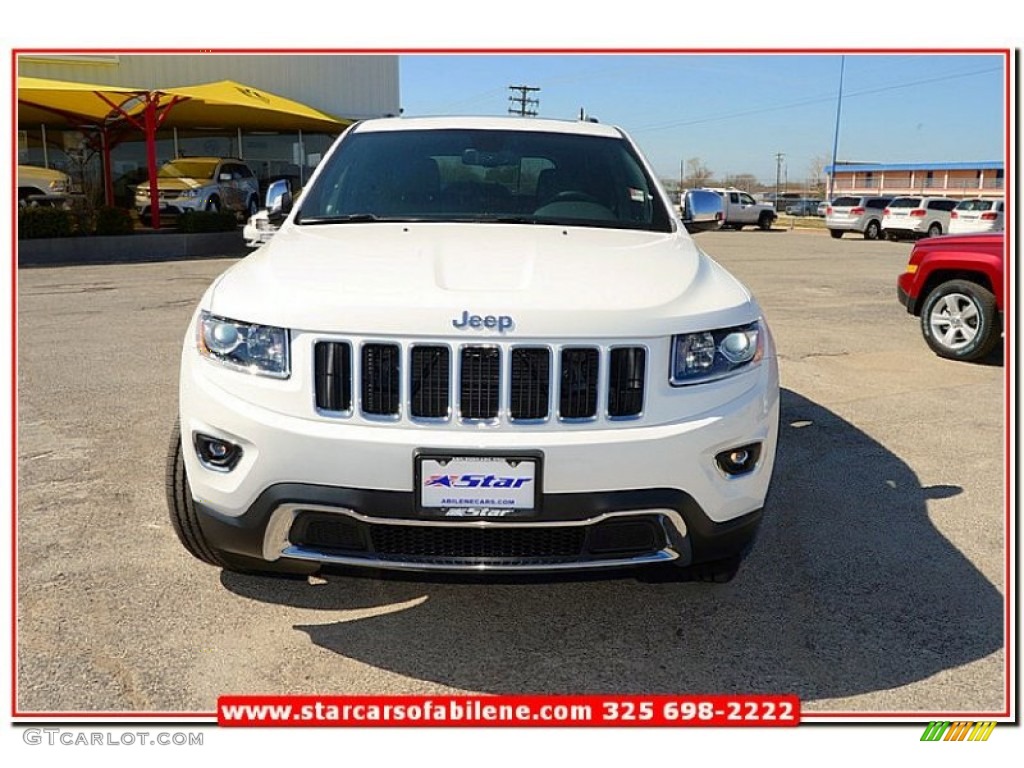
[671,323,764,386]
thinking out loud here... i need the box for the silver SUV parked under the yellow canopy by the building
[135,158,259,222]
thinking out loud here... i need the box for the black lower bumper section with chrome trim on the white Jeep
[196,483,762,571]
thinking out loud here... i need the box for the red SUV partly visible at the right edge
[896,232,1006,360]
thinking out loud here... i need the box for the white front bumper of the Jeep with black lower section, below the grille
[180,327,779,571]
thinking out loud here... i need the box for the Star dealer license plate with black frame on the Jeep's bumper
[416,456,540,517]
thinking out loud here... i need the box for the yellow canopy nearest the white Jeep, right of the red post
[161,80,352,133]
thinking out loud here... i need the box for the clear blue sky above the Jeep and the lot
[399,52,1006,184]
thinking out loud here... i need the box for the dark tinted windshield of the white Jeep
[296,129,672,231]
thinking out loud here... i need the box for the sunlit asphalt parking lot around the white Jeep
[16,230,1007,714]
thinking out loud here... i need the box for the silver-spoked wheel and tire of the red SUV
[921,280,1001,360]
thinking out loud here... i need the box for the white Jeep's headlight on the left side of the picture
[197,312,291,379]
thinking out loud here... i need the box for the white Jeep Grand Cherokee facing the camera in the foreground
[167,118,779,581]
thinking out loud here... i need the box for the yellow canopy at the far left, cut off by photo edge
[17,77,148,126]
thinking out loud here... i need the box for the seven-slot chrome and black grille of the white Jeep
[313,341,647,424]
